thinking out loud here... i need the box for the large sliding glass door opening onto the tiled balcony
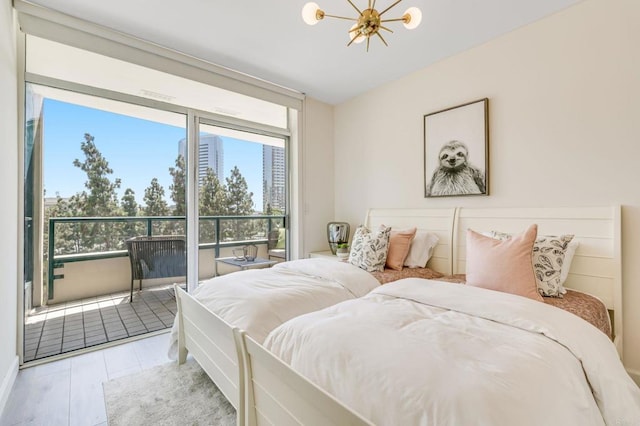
[22,35,292,362]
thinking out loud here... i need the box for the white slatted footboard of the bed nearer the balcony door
[174,285,245,425]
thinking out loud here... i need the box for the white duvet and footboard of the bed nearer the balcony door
[169,259,379,421]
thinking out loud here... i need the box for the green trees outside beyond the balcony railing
[44,133,282,257]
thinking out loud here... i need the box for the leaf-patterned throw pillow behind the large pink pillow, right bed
[490,231,577,297]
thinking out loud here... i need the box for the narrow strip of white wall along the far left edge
[0,0,18,412]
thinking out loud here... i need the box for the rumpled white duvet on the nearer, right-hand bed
[264,278,640,426]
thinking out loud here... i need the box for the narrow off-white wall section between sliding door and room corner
[300,98,334,255]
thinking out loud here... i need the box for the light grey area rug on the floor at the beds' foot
[102,360,236,426]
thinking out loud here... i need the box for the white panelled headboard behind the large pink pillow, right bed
[452,206,622,354]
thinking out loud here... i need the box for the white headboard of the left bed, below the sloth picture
[364,208,456,275]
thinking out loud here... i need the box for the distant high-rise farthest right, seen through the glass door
[262,145,286,212]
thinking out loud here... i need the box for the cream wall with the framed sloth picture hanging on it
[335,0,640,372]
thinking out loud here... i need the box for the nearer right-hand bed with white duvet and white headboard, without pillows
[245,206,640,425]
